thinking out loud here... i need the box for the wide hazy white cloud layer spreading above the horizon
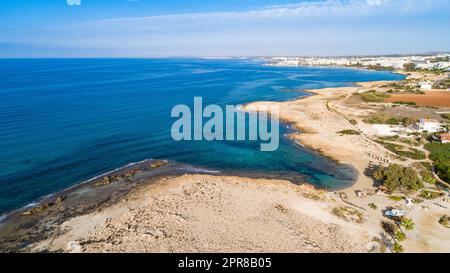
[0,0,450,55]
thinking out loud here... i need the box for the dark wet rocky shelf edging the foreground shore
[0,156,344,253]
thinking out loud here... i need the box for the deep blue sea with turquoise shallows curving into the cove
[0,59,401,213]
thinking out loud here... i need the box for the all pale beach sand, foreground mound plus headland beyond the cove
[1,72,450,253]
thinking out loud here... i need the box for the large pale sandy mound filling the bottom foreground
[31,175,372,252]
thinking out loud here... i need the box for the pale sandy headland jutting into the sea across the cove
[243,82,394,191]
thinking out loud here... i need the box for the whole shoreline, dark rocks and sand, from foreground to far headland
[0,67,449,252]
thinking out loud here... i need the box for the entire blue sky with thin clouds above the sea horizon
[0,0,450,57]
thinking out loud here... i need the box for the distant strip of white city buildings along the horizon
[269,54,450,69]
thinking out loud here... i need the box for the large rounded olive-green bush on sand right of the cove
[373,164,423,193]
